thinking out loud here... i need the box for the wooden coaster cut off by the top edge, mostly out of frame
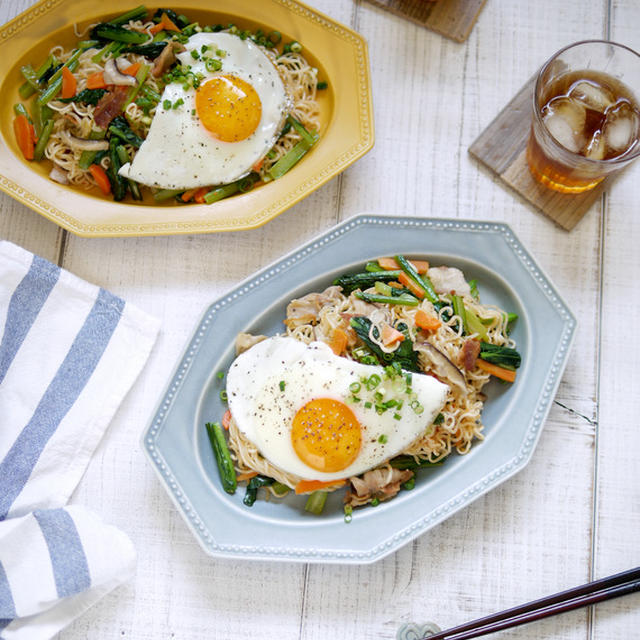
[368,0,487,42]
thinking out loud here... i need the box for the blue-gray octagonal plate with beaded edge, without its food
[142,215,576,563]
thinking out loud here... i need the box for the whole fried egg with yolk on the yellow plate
[119,33,289,189]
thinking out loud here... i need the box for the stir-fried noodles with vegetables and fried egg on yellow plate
[14,6,327,204]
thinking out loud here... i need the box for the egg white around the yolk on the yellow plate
[119,33,289,189]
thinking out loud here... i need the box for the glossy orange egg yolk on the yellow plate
[196,75,262,142]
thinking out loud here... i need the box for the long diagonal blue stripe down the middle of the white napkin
[0,289,124,520]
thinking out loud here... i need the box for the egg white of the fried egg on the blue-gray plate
[227,337,448,480]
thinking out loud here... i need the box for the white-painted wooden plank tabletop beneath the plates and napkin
[0,0,640,640]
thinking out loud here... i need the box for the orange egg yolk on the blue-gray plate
[291,398,362,473]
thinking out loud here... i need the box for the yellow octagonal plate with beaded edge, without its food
[0,0,374,237]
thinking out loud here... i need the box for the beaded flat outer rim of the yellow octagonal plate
[0,0,375,238]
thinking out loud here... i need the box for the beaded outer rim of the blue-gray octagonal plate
[140,212,577,564]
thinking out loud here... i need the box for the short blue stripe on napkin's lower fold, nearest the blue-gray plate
[33,509,91,598]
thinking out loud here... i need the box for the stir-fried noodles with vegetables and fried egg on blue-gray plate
[206,255,521,520]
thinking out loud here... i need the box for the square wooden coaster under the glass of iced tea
[469,77,614,231]
